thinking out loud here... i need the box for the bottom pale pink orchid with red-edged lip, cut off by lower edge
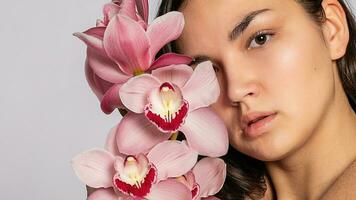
[72,141,198,200]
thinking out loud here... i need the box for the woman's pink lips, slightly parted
[241,112,277,138]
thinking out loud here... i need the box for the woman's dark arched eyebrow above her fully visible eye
[229,8,271,41]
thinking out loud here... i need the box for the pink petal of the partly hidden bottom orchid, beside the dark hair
[193,157,226,197]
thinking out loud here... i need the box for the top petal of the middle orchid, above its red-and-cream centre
[152,65,193,88]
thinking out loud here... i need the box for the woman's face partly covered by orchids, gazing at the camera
[177,0,336,161]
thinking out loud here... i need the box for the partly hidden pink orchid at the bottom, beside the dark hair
[177,157,226,200]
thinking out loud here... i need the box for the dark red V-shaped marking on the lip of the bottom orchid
[114,165,157,197]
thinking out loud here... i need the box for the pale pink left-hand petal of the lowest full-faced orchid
[72,149,115,188]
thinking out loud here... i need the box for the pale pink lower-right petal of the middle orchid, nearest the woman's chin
[181,108,229,157]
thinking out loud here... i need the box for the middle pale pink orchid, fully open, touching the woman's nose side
[116,61,228,157]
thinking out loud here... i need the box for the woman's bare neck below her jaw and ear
[266,76,356,200]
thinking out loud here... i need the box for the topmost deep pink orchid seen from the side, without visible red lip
[75,10,191,114]
